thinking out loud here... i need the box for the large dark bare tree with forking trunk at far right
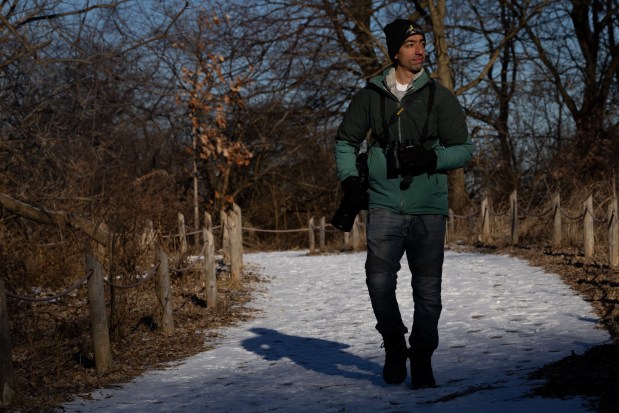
[513,0,619,180]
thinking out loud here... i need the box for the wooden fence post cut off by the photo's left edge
[0,280,15,407]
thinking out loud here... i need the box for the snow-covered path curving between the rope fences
[63,250,610,413]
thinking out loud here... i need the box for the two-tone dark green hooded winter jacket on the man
[335,69,473,215]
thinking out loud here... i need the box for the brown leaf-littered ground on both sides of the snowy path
[0,245,619,413]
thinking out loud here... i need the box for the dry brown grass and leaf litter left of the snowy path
[0,260,261,413]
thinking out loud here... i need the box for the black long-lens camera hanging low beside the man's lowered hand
[331,152,369,232]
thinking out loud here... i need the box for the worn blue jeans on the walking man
[365,208,446,351]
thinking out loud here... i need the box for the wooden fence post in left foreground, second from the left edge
[86,253,112,372]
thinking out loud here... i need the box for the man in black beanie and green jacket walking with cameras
[334,19,473,389]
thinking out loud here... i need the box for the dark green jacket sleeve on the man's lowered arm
[335,88,370,182]
